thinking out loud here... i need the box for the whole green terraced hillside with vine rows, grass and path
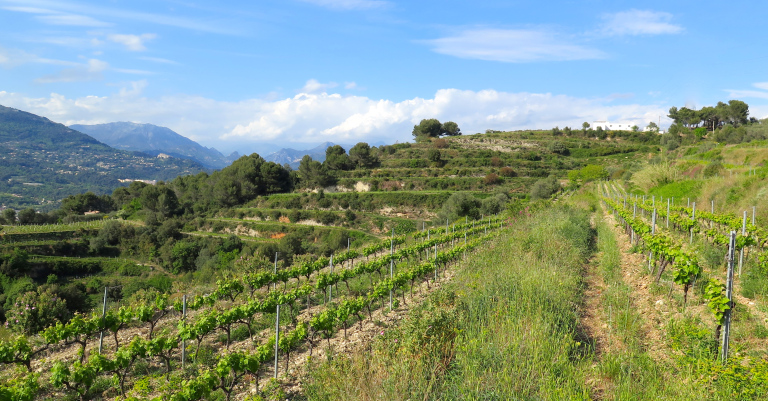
[0,123,768,401]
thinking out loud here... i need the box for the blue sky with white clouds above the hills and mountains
[0,0,768,154]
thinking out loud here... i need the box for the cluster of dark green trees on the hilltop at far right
[667,100,754,130]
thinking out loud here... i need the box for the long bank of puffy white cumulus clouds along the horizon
[0,86,668,148]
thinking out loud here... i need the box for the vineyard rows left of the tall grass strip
[0,218,503,400]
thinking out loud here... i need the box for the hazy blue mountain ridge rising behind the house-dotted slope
[69,122,231,169]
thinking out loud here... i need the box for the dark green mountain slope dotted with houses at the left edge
[0,106,207,209]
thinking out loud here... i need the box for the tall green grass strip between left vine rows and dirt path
[305,208,593,400]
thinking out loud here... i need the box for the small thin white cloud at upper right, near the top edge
[601,9,683,36]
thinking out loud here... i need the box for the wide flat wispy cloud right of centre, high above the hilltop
[423,29,605,63]
